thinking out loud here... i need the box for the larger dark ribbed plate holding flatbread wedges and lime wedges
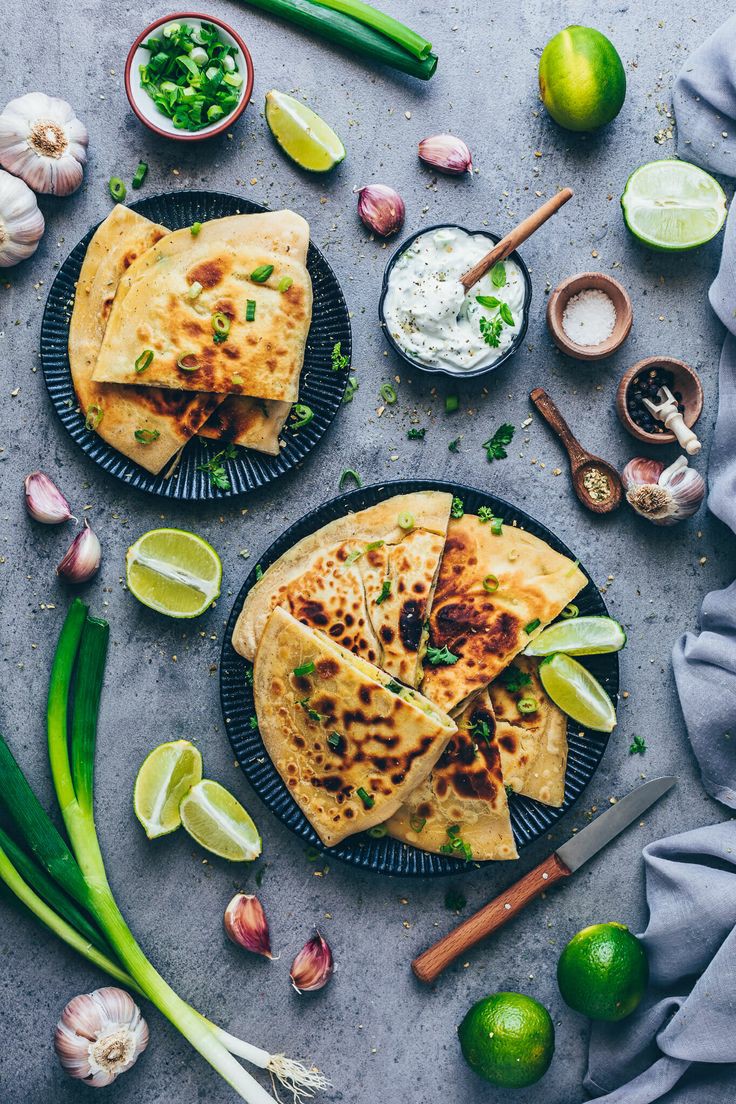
[220,479,618,875]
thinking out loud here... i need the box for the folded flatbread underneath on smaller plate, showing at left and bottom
[68,204,222,473]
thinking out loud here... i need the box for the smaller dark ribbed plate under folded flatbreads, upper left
[41,192,351,501]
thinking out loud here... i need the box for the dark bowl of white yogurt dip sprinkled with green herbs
[378,224,532,379]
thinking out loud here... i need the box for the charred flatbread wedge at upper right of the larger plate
[422,513,586,712]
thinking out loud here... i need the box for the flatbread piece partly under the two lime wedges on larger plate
[489,656,567,808]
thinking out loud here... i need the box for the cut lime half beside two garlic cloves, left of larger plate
[126,529,222,617]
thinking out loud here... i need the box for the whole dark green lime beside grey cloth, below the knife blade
[557,924,649,1021]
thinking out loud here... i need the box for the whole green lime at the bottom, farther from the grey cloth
[458,992,555,1089]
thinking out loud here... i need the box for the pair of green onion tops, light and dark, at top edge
[236,0,437,81]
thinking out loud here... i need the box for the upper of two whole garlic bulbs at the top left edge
[0,92,89,195]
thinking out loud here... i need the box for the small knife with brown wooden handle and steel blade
[412,776,678,983]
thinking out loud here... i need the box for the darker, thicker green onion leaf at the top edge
[236,0,437,81]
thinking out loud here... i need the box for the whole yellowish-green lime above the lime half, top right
[540,26,626,130]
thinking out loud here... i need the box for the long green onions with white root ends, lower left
[0,598,328,1104]
